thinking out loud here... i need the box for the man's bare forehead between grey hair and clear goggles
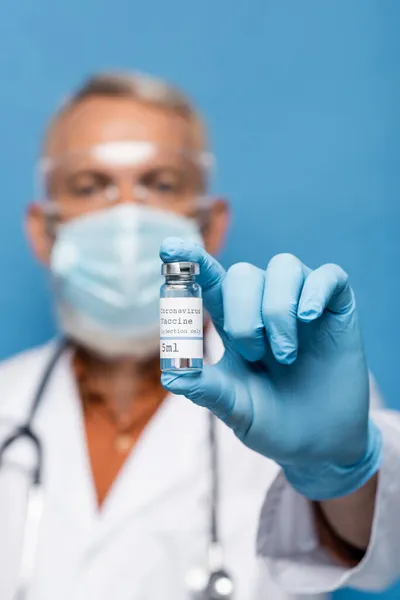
[44,97,204,158]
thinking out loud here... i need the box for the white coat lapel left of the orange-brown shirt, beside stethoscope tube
[35,350,97,532]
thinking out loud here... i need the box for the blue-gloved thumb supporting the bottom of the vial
[161,365,253,439]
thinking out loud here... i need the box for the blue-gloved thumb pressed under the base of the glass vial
[161,366,247,430]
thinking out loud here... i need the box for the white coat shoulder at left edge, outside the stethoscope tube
[0,341,56,421]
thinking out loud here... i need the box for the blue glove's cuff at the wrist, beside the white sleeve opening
[283,420,383,501]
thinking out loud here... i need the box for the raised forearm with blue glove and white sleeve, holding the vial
[161,239,394,593]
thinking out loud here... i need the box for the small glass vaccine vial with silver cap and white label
[160,262,203,373]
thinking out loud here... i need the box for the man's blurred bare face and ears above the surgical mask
[28,96,227,263]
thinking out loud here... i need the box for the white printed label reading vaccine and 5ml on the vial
[160,298,203,358]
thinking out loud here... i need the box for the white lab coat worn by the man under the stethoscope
[0,332,400,600]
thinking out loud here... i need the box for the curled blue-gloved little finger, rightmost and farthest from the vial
[298,264,355,321]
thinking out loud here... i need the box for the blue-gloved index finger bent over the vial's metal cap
[160,237,225,329]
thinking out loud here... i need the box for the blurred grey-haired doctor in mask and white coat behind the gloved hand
[0,74,400,600]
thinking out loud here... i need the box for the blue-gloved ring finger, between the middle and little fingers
[262,254,306,364]
